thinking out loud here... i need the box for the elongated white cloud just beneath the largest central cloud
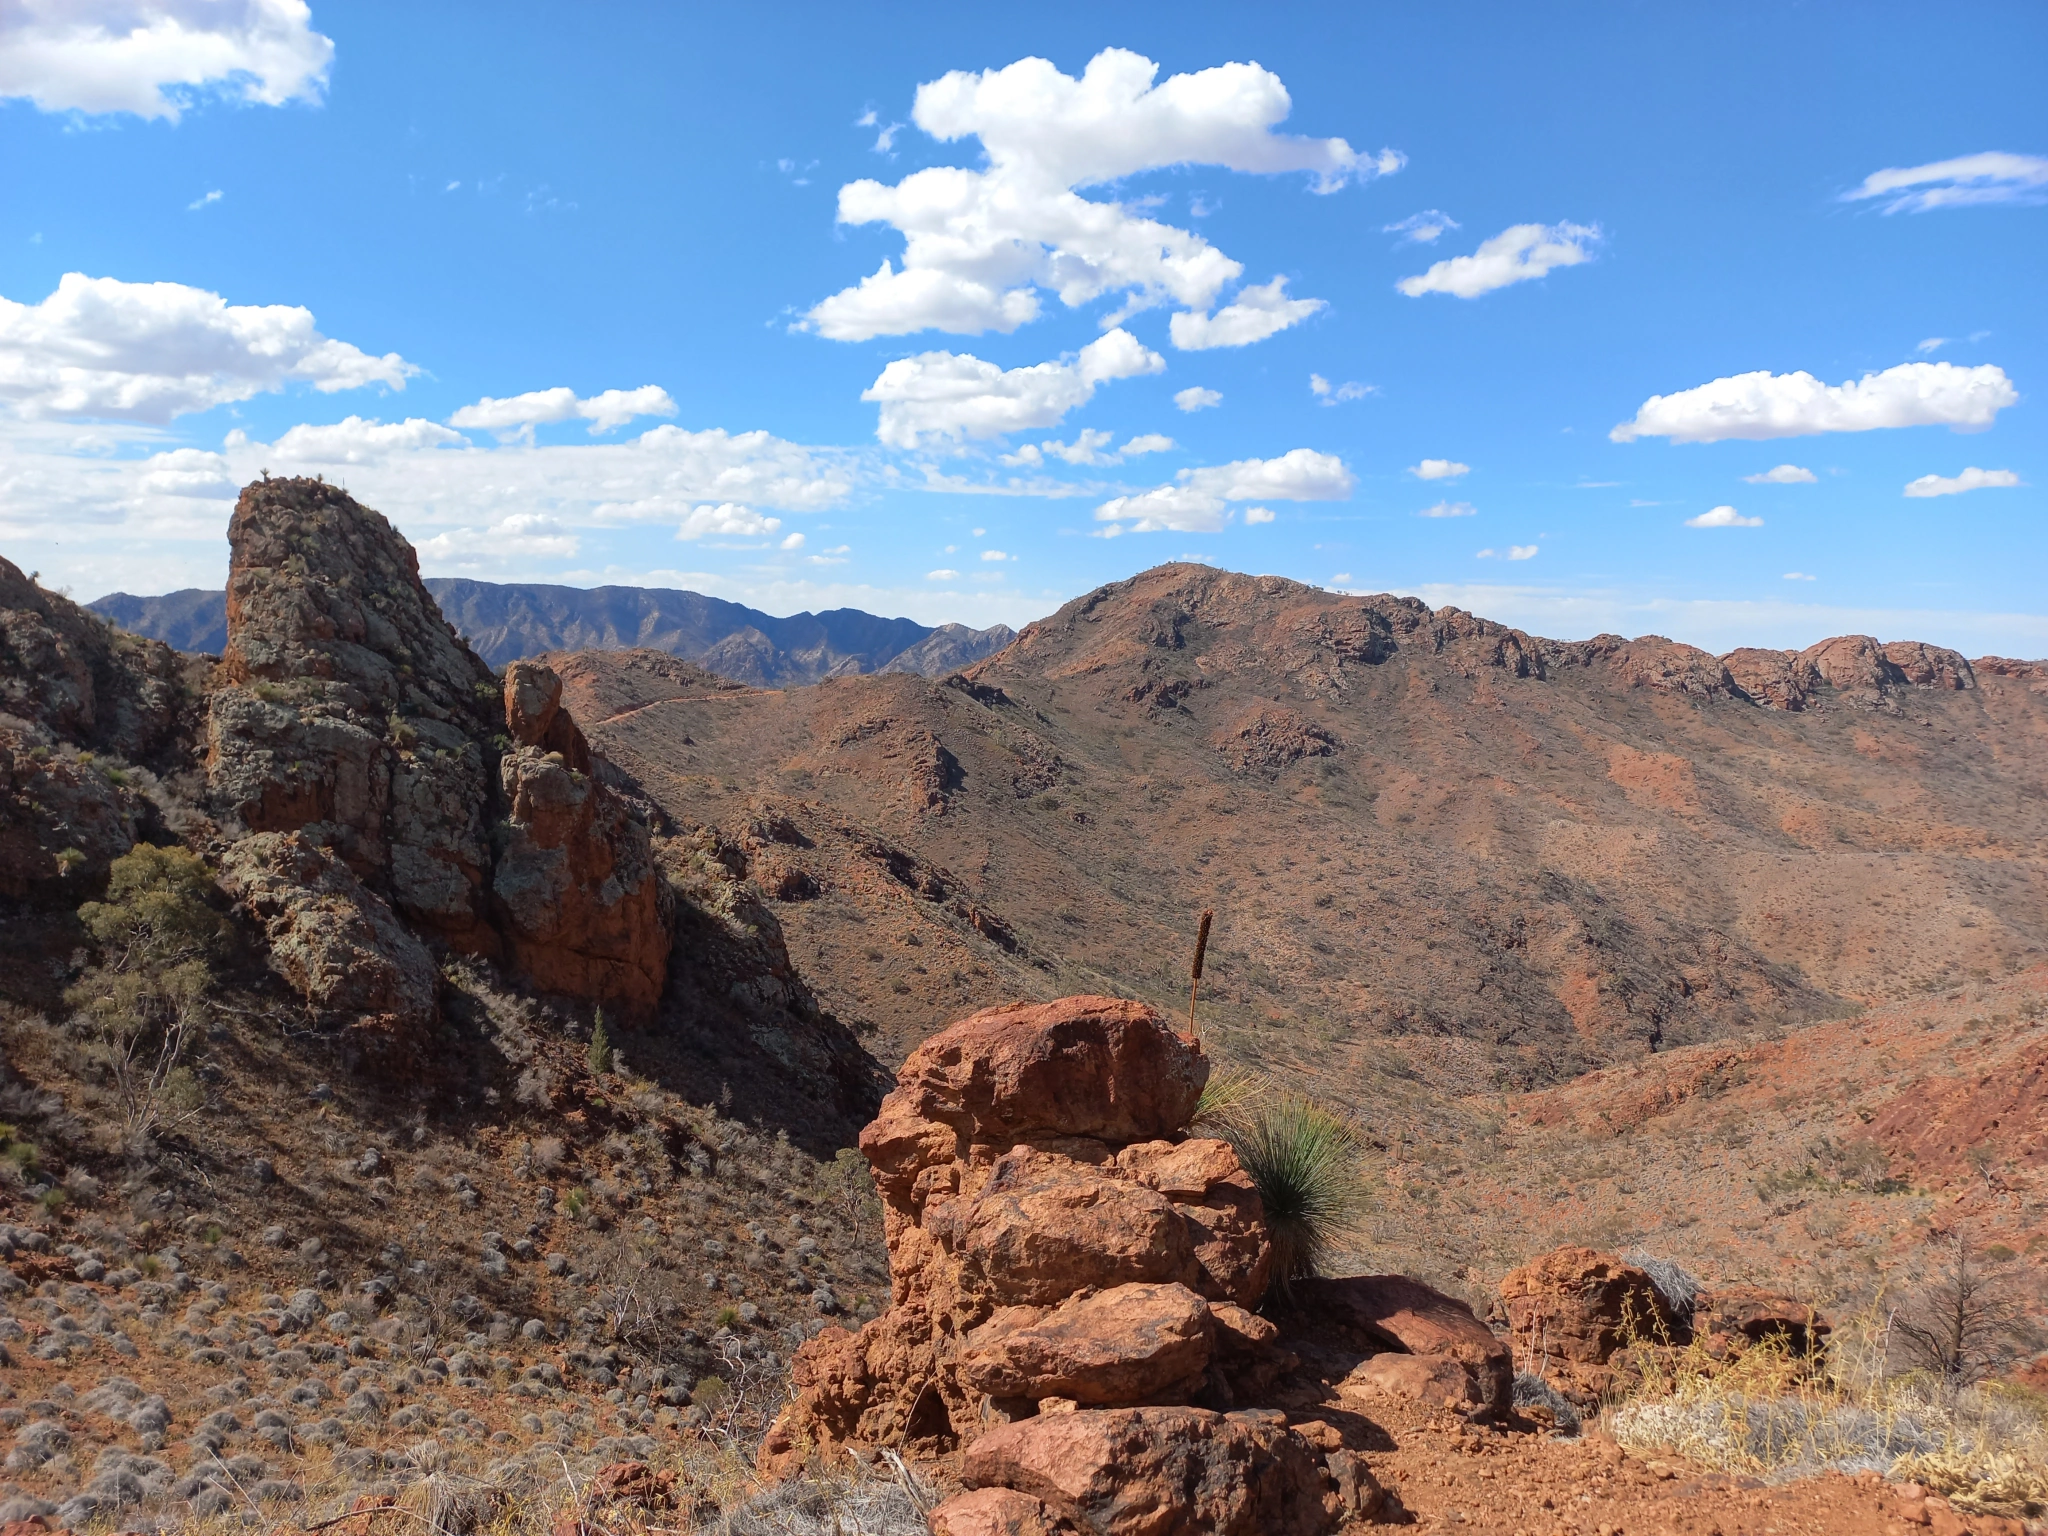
[860,326,1165,449]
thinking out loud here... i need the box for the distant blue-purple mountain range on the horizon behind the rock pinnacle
[86,578,1016,688]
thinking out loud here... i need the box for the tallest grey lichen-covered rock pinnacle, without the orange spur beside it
[207,479,498,954]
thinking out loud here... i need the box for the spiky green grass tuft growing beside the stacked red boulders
[1214,1090,1366,1294]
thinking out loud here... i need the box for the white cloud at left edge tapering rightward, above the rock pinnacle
[0,272,418,424]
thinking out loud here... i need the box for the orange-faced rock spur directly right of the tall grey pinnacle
[492,662,670,1018]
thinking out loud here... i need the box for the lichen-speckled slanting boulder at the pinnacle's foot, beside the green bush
[221,831,440,1067]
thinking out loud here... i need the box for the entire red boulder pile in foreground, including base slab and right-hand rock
[762,997,1511,1536]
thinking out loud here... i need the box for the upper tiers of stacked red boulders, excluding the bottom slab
[764,997,1274,1466]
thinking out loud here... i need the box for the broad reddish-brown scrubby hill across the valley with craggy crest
[563,565,2048,1096]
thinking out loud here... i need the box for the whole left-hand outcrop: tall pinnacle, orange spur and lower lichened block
[207,479,670,1055]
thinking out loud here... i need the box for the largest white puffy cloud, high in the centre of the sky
[801,49,1401,346]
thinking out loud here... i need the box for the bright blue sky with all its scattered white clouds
[0,0,2048,655]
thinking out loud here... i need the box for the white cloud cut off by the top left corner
[0,0,334,121]
